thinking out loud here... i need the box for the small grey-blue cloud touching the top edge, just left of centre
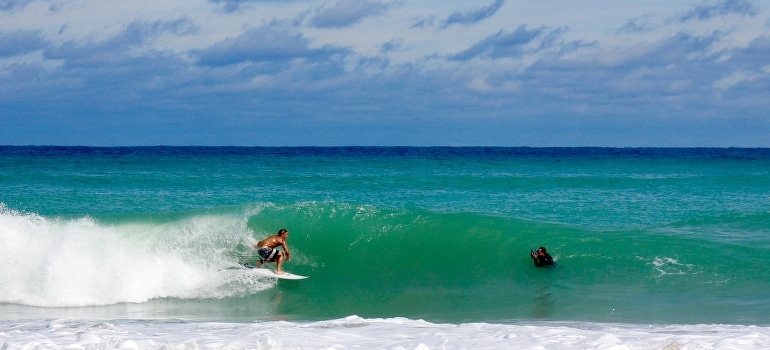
[310,0,391,28]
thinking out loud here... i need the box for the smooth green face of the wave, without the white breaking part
[222,202,770,321]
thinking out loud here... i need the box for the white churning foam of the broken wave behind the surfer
[0,206,274,307]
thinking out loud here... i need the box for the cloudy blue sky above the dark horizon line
[0,0,770,147]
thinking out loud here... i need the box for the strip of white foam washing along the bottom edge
[0,316,770,350]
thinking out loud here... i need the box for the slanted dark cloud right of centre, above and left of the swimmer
[451,25,554,61]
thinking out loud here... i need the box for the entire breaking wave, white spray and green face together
[7,201,770,323]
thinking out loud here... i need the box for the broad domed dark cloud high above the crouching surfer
[196,27,346,66]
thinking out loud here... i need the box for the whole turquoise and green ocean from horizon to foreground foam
[0,146,770,350]
